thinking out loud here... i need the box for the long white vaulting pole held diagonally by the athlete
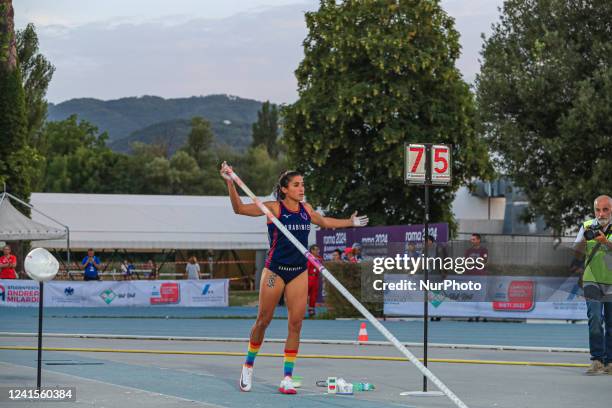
[229,167,468,408]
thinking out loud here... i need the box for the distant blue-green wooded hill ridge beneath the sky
[47,95,262,152]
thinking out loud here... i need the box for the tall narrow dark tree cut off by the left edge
[0,0,40,209]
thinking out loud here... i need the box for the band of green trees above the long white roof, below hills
[39,116,284,195]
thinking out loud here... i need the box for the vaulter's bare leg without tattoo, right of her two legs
[285,271,308,350]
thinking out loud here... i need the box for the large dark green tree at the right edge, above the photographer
[476,0,612,234]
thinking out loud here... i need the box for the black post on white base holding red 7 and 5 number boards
[400,143,452,396]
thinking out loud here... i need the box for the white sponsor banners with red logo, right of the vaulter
[384,274,587,320]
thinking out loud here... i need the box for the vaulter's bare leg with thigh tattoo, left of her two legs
[251,268,285,343]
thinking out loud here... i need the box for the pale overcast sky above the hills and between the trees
[13,0,503,103]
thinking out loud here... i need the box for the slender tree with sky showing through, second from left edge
[17,23,55,147]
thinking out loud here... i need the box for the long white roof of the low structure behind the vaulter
[31,193,270,250]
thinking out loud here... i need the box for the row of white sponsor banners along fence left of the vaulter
[0,279,229,307]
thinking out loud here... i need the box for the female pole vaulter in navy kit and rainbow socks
[221,162,368,394]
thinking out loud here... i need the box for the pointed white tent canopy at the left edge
[0,193,66,242]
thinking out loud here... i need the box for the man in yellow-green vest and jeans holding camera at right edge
[575,195,612,375]
